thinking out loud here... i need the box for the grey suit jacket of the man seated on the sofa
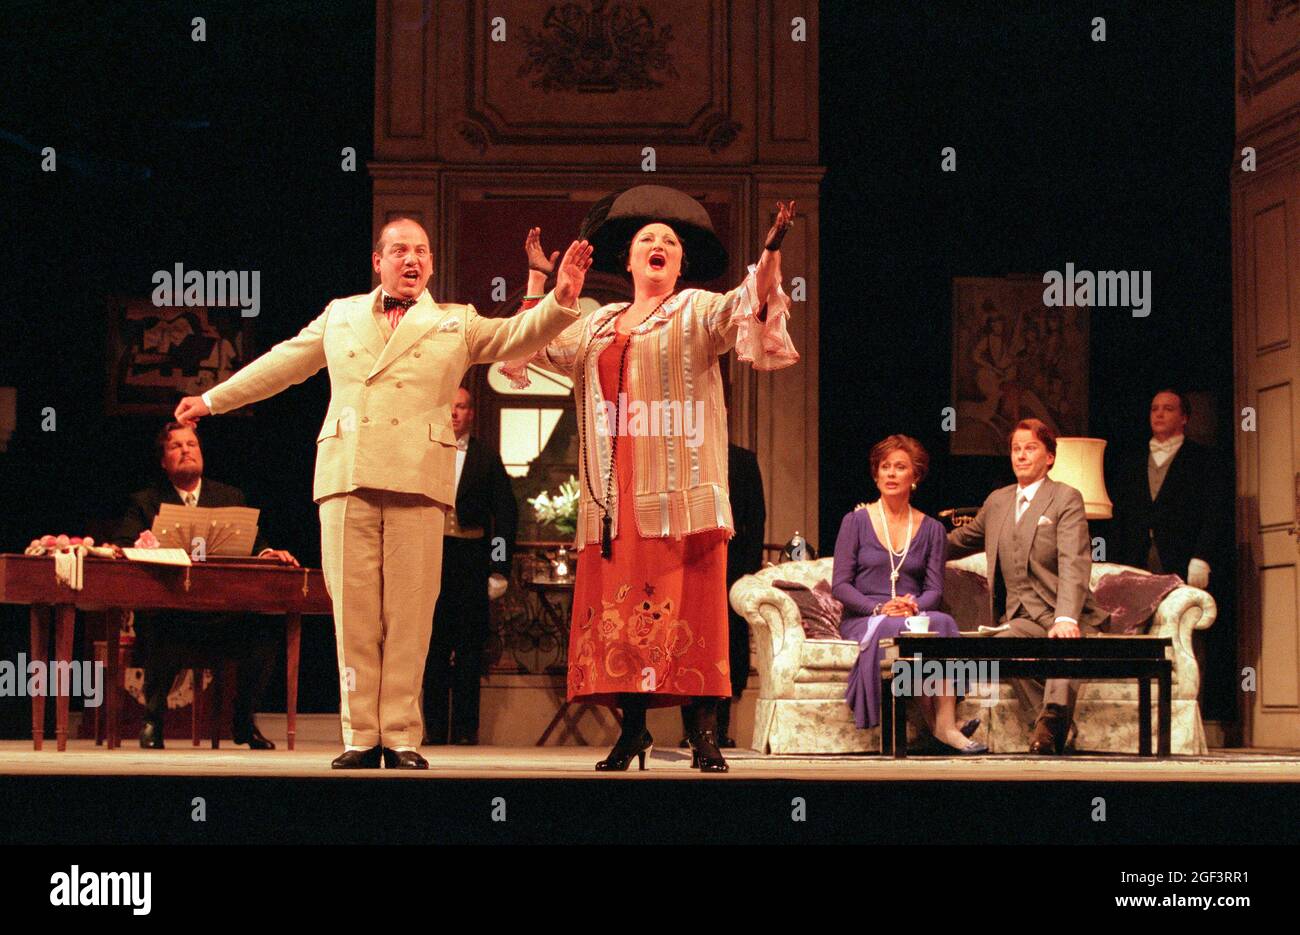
[948,477,1108,627]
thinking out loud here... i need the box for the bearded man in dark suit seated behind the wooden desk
[113,423,298,750]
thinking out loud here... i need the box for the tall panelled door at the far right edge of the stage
[1232,0,1300,746]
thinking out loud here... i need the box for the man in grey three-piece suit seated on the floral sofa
[948,419,1106,753]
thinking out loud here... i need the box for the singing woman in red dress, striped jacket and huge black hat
[504,186,798,772]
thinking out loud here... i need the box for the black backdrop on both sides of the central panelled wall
[0,0,1235,736]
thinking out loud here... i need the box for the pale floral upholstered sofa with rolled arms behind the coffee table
[731,553,1218,754]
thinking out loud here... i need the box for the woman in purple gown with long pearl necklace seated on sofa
[832,434,985,753]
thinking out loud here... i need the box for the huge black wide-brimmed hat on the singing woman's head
[579,185,727,282]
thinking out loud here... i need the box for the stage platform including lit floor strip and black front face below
[0,737,1300,845]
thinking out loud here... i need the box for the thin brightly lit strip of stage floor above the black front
[0,739,1300,783]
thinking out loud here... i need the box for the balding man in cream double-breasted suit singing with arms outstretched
[176,218,592,769]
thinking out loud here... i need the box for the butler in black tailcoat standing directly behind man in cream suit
[424,388,519,744]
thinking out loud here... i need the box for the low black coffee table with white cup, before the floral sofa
[880,633,1174,759]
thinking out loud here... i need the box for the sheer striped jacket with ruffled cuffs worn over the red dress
[501,267,800,549]
